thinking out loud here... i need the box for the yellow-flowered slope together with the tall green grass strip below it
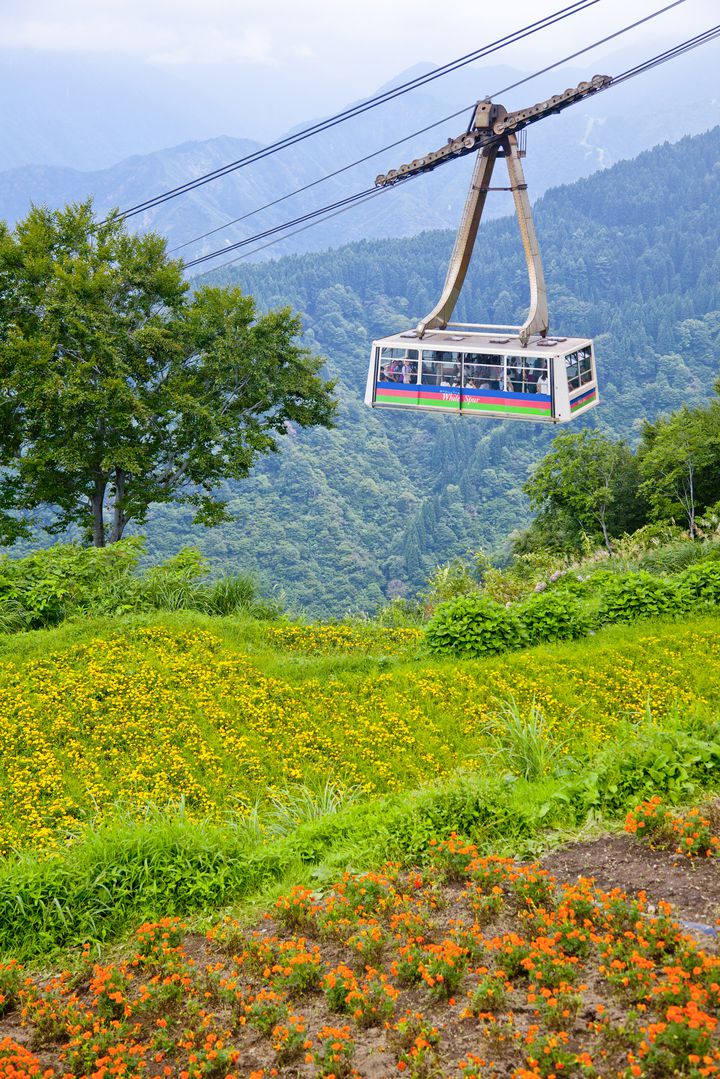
[0,582,720,971]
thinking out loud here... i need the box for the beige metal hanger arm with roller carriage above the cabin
[375,74,612,347]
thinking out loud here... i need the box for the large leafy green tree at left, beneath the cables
[0,203,335,546]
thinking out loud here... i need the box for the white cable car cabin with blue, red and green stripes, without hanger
[365,329,598,423]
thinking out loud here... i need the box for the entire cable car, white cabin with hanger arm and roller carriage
[365,76,611,423]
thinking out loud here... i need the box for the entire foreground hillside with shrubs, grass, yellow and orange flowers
[0,525,720,1079]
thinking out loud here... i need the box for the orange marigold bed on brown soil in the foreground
[5,837,720,1079]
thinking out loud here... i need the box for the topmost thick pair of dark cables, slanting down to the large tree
[105,0,601,218]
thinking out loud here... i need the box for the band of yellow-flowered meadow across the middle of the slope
[5,614,720,853]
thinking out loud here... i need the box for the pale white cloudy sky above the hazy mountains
[0,0,720,138]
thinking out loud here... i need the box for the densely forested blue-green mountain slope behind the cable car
[140,127,720,615]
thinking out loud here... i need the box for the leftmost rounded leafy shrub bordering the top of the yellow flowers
[425,596,524,656]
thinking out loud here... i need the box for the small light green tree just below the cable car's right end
[525,428,642,552]
